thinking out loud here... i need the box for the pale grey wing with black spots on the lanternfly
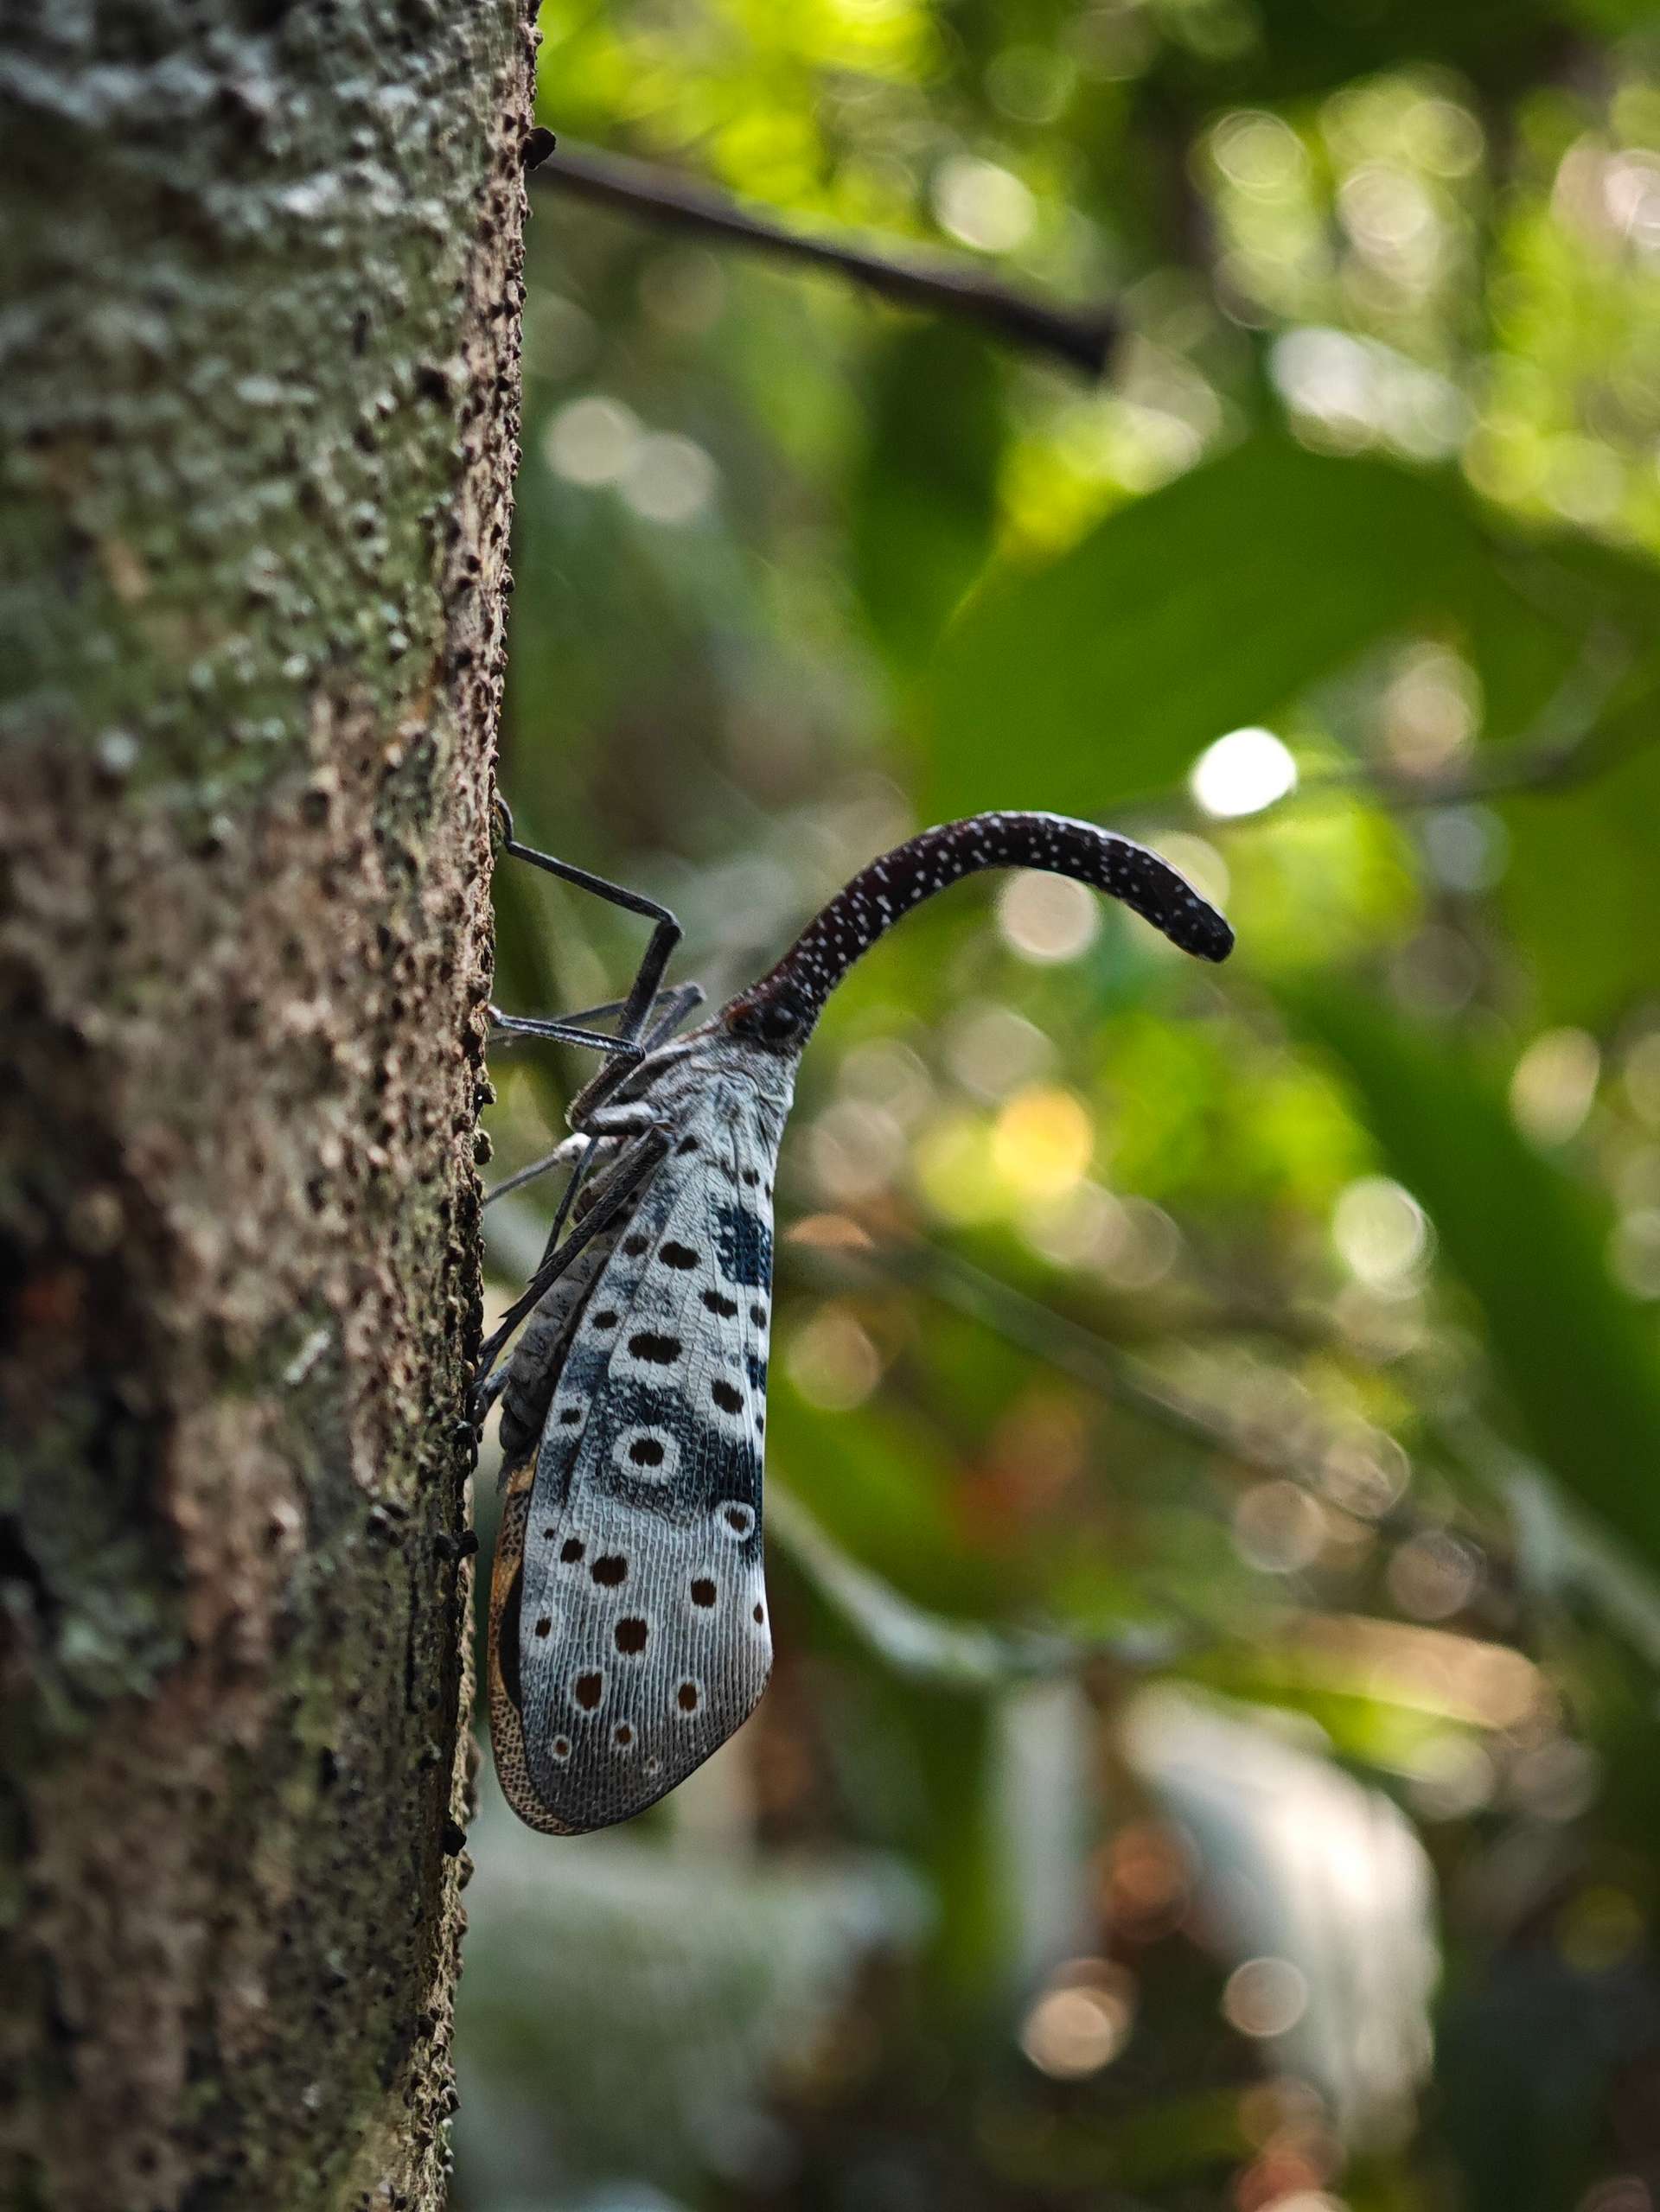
[501,1084,775,1833]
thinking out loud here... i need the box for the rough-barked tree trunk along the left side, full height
[0,0,533,2212]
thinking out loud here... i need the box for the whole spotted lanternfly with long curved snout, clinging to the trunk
[478,810,1233,1836]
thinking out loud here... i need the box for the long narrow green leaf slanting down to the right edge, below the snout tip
[1286,986,1660,1566]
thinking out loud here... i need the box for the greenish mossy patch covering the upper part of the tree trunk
[0,0,527,792]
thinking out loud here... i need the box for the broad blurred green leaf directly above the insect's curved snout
[923,436,1485,814]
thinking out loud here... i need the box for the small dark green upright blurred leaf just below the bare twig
[850,323,1003,664]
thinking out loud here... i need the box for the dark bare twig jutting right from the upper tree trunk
[529,133,1122,376]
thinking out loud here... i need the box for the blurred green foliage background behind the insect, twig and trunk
[456,0,1660,2212]
